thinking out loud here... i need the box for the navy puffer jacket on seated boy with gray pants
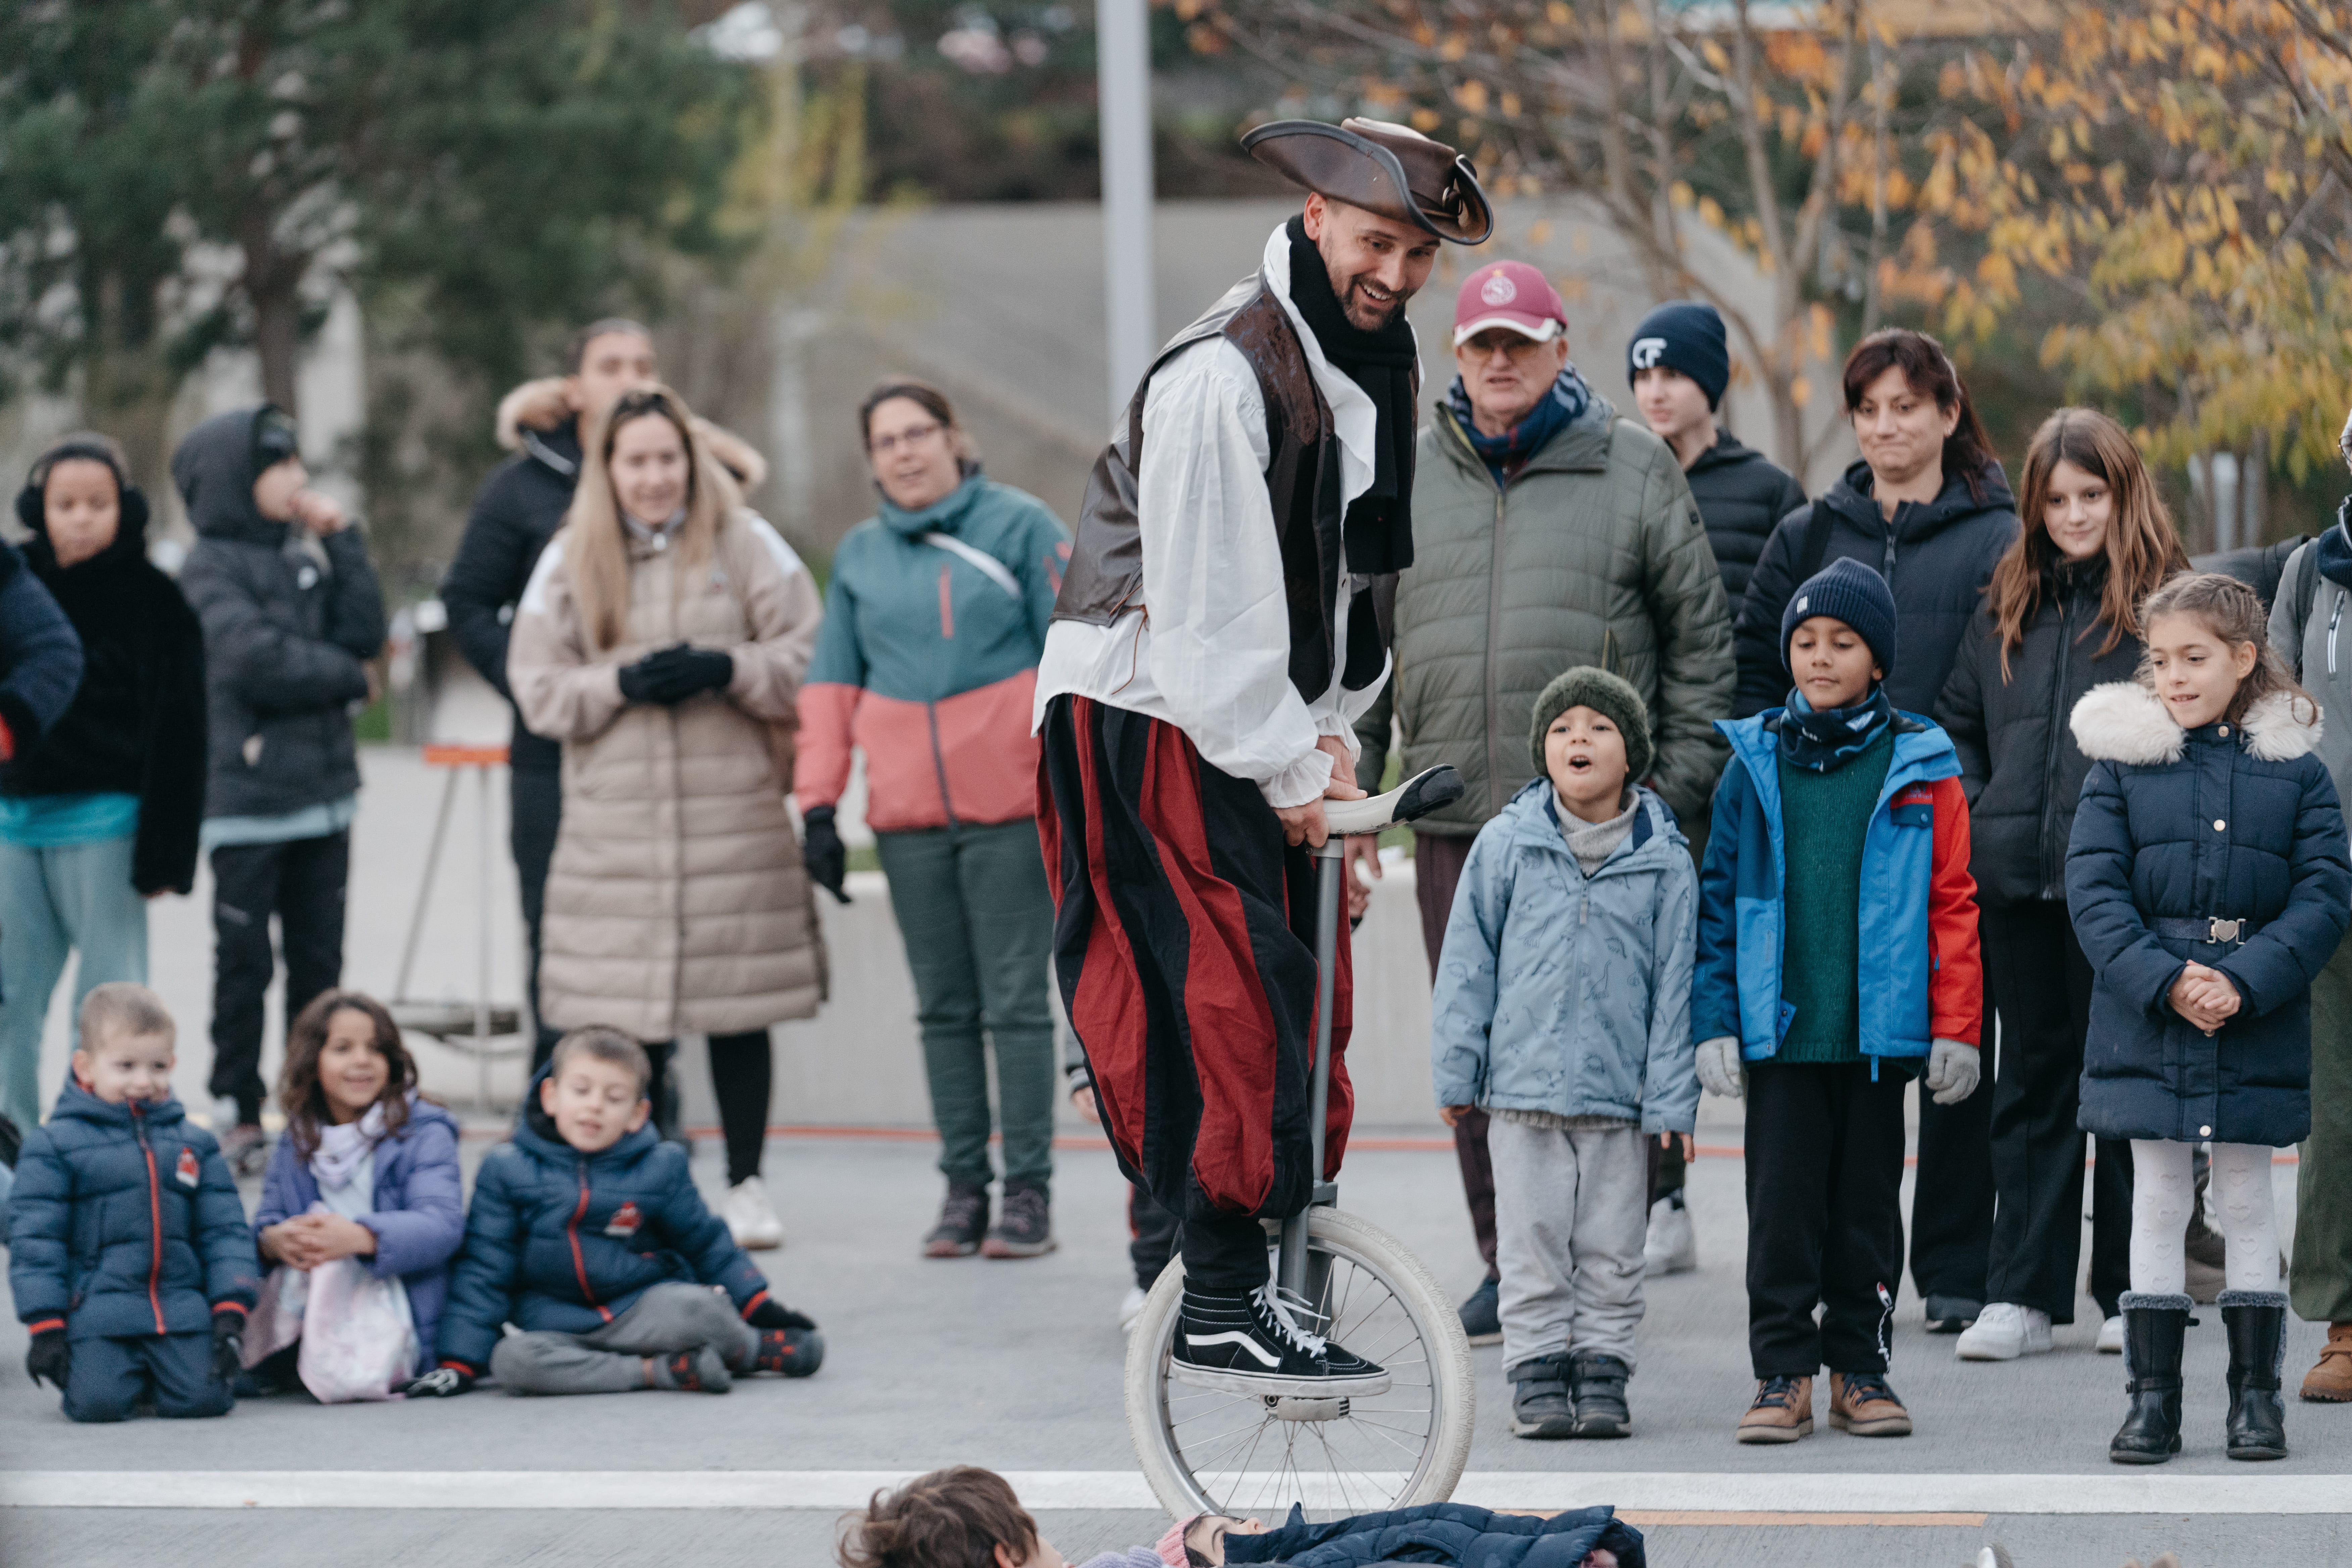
[437,1067,767,1375]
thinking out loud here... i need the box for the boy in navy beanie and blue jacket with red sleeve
[1691,559,1983,1443]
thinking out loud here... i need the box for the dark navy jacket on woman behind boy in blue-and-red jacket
[1733,463,2018,719]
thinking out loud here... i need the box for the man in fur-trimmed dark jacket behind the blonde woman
[442,317,661,1065]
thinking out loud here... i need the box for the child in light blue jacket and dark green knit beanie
[1430,665,1698,1439]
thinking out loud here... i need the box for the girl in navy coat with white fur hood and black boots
[2065,574,2352,1465]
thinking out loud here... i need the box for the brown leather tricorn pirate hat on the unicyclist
[1242,120,1493,244]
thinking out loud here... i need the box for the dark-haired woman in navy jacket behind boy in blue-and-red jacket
[1736,327,2018,1333]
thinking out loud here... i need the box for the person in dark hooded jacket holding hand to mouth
[172,404,383,1171]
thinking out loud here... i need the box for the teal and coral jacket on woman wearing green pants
[793,475,1070,832]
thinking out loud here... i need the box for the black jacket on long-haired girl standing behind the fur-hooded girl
[1936,555,2143,905]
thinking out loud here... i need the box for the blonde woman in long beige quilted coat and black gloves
[506,388,823,1246]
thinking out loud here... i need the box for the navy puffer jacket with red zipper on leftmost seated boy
[7,1079,261,1340]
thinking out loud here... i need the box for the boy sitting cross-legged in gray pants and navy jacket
[407,1027,826,1396]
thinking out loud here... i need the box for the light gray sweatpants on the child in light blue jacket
[1486,1117,1649,1371]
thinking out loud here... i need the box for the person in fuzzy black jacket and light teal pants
[0,435,205,1126]
